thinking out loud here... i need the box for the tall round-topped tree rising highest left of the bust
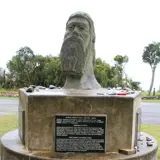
[7,47,36,86]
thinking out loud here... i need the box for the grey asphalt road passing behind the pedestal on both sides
[0,98,160,125]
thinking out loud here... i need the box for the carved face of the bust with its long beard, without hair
[60,17,91,77]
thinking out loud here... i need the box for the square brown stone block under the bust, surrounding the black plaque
[19,89,141,152]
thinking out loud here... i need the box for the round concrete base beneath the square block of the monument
[1,130,158,160]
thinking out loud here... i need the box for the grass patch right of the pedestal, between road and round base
[141,125,160,160]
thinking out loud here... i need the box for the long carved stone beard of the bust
[60,36,85,77]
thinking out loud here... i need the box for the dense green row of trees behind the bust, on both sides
[0,46,140,90]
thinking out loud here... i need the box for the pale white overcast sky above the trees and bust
[0,0,160,90]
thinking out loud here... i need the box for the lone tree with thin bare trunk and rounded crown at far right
[142,42,160,95]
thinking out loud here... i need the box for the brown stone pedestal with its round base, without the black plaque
[1,89,158,160]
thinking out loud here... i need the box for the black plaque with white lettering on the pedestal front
[55,115,106,152]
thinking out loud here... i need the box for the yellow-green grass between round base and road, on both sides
[0,114,160,160]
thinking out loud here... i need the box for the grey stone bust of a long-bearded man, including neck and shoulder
[60,12,101,89]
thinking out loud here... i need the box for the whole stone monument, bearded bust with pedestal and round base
[1,12,158,160]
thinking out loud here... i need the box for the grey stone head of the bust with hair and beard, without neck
[60,12,95,78]
